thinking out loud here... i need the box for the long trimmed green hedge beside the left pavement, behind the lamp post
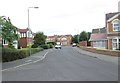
[2,48,43,62]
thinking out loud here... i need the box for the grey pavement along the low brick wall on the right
[75,47,118,64]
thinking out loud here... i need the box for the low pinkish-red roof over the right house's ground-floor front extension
[89,33,107,41]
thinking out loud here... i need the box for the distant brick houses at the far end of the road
[46,35,72,46]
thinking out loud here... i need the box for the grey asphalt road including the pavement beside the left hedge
[2,46,118,81]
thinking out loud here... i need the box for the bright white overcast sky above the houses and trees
[0,0,119,36]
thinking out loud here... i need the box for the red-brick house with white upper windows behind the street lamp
[19,28,33,48]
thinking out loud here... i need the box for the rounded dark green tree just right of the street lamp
[34,32,46,47]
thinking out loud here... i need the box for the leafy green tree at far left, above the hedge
[0,17,19,48]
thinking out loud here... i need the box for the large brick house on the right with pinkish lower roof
[89,12,120,50]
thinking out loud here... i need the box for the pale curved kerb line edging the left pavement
[1,51,48,71]
